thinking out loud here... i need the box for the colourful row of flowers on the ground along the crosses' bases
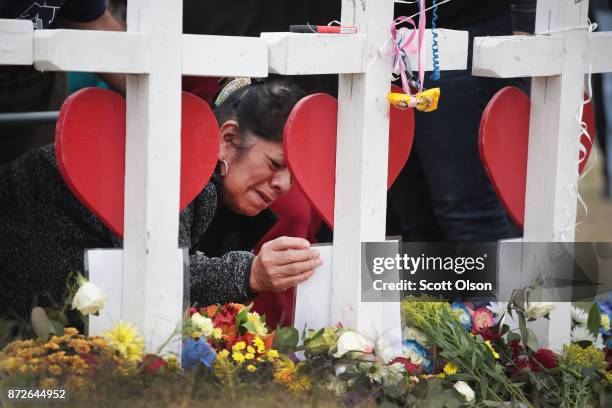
[0,282,612,407]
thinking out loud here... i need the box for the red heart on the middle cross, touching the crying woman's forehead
[284,90,414,228]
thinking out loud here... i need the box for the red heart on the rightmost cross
[478,87,595,228]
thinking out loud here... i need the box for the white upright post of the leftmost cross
[121,0,183,352]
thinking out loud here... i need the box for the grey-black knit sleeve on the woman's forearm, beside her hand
[189,251,255,306]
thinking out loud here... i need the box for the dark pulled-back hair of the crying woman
[214,77,306,147]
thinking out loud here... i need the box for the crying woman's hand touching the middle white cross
[250,237,323,292]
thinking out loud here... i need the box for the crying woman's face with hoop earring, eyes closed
[219,121,291,216]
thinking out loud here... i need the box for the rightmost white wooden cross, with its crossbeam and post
[473,0,612,349]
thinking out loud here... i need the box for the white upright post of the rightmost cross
[523,0,589,350]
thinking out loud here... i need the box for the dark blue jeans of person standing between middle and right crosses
[387,11,528,242]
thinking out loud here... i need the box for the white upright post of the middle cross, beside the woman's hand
[331,0,400,338]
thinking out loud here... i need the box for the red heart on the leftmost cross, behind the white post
[55,88,219,237]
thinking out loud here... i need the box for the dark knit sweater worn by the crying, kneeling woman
[0,145,253,318]
